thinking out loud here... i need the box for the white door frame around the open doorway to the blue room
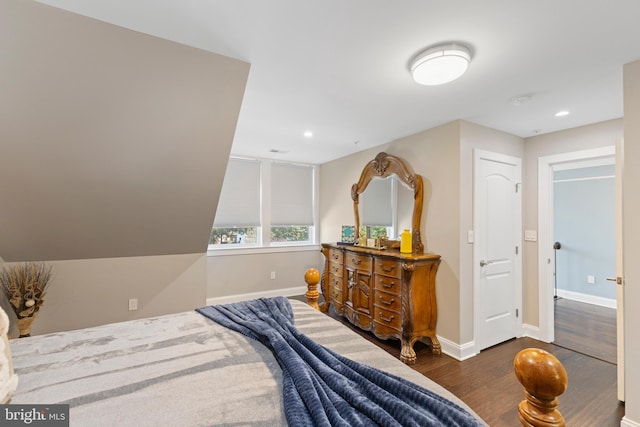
[538,145,616,342]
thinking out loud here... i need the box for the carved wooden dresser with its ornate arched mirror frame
[320,153,441,364]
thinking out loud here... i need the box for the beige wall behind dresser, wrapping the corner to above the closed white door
[320,121,523,344]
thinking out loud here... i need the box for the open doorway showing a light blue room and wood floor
[553,156,616,364]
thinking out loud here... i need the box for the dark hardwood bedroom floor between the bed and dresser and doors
[296,298,624,427]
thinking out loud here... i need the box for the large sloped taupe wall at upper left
[0,0,249,261]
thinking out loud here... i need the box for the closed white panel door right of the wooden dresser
[474,150,522,350]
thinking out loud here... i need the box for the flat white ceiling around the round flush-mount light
[39,0,640,163]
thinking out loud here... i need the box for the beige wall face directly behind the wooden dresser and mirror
[320,122,459,342]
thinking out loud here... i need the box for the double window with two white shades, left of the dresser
[209,158,316,250]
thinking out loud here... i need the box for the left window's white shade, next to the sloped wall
[213,159,260,227]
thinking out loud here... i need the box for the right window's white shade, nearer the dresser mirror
[271,163,313,226]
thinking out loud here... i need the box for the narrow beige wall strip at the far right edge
[622,61,640,427]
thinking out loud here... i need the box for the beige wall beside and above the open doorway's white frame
[523,119,623,326]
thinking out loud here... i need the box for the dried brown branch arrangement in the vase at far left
[0,262,52,319]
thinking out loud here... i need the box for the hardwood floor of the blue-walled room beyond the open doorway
[553,298,617,364]
